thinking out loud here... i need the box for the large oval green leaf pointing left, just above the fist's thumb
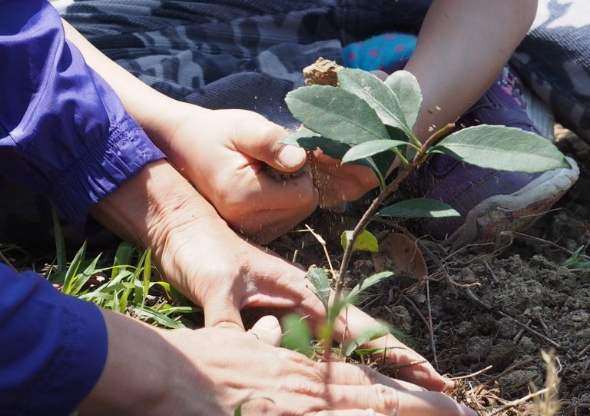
[285,85,389,145]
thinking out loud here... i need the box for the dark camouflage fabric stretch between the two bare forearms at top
[62,0,429,127]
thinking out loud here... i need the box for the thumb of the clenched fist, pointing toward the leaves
[234,120,307,172]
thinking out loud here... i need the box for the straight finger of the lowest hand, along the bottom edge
[328,384,477,416]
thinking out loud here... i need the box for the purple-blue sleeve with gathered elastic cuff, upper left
[0,0,164,228]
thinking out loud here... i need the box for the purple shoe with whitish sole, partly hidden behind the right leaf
[405,67,579,247]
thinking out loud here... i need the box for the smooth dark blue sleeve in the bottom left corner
[0,264,107,416]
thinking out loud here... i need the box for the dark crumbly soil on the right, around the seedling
[275,131,590,416]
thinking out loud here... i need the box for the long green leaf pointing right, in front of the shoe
[431,125,570,173]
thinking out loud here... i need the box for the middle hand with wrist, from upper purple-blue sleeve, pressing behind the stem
[92,161,448,390]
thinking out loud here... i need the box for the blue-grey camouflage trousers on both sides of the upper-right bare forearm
[54,0,590,140]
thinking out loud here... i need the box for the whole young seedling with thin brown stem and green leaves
[283,65,570,357]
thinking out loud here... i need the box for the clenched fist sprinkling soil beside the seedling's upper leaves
[161,104,318,242]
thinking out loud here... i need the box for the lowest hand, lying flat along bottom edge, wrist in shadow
[80,311,475,416]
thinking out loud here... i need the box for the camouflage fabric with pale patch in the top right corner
[512,0,590,141]
